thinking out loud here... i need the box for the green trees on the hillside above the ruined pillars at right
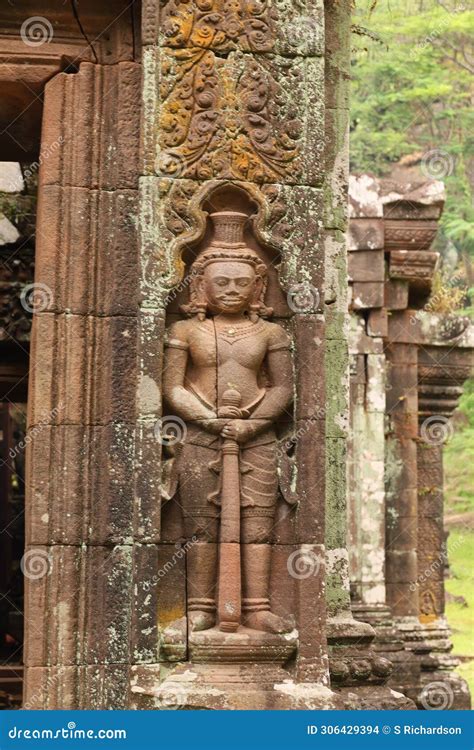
[351,0,474,313]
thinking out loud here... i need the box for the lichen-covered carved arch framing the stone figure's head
[140,178,316,317]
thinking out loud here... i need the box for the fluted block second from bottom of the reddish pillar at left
[24,545,132,667]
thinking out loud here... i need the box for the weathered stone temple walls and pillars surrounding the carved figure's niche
[2,0,472,708]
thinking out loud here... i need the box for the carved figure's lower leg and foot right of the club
[242,508,295,633]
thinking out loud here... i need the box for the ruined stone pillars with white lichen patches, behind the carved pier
[348,175,468,708]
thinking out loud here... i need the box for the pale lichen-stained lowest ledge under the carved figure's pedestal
[131,663,345,711]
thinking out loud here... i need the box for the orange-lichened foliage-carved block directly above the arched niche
[144,46,324,185]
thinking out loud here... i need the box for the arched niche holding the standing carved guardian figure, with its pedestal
[132,183,337,708]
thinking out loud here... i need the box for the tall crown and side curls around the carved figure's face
[181,211,272,319]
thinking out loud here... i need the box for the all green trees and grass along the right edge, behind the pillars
[351,0,474,694]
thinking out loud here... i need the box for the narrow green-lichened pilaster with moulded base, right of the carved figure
[325,14,412,708]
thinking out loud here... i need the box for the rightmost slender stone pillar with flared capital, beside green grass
[414,326,474,709]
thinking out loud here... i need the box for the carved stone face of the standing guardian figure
[202,261,260,314]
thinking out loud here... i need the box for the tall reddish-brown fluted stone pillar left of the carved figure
[24,62,141,708]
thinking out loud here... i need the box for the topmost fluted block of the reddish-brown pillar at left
[40,62,141,190]
